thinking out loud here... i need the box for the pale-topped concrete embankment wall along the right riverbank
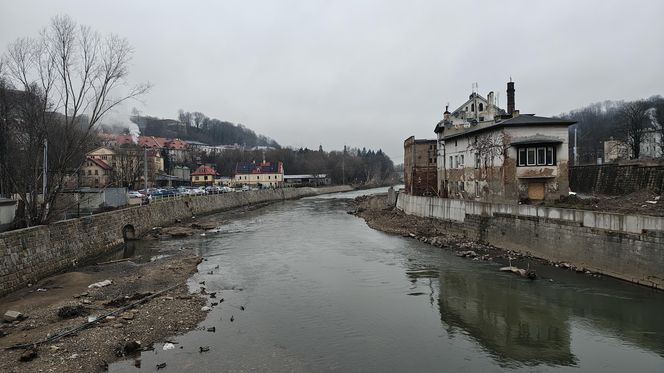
[397,194,664,289]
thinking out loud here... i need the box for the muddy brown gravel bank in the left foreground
[0,249,207,372]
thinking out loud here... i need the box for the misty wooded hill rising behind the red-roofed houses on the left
[129,109,279,147]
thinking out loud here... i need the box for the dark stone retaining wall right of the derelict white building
[570,164,664,195]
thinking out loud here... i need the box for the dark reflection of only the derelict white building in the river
[438,270,575,365]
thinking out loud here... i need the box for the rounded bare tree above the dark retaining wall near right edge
[618,100,651,159]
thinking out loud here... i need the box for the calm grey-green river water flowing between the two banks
[110,187,664,372]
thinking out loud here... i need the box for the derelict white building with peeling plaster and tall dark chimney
[435,81,575,202]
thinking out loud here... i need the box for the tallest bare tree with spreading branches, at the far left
[0,16,149,226]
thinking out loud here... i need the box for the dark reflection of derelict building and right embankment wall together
[406,258,664,368]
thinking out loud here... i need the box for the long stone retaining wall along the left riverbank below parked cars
[0,186,352,296]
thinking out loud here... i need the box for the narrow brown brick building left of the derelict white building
[403,136,438,196]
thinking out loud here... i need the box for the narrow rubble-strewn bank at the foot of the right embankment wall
[349,194,600,280]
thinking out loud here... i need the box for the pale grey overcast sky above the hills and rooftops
[0,0,664,163]
